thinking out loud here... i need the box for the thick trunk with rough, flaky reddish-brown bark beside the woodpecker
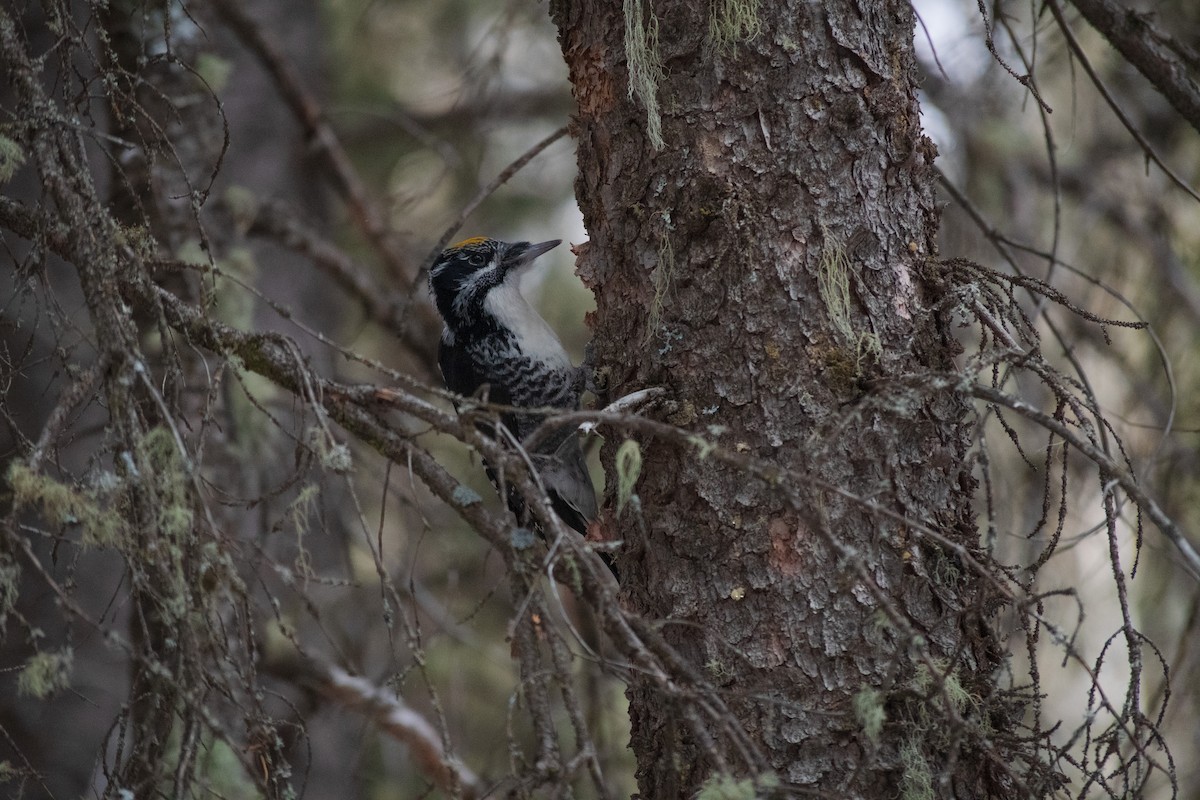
[552,0,1017,798]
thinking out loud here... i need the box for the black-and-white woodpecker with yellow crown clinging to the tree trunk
[430,236,607,551]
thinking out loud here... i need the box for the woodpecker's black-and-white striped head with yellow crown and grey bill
[430,236,562,330]
